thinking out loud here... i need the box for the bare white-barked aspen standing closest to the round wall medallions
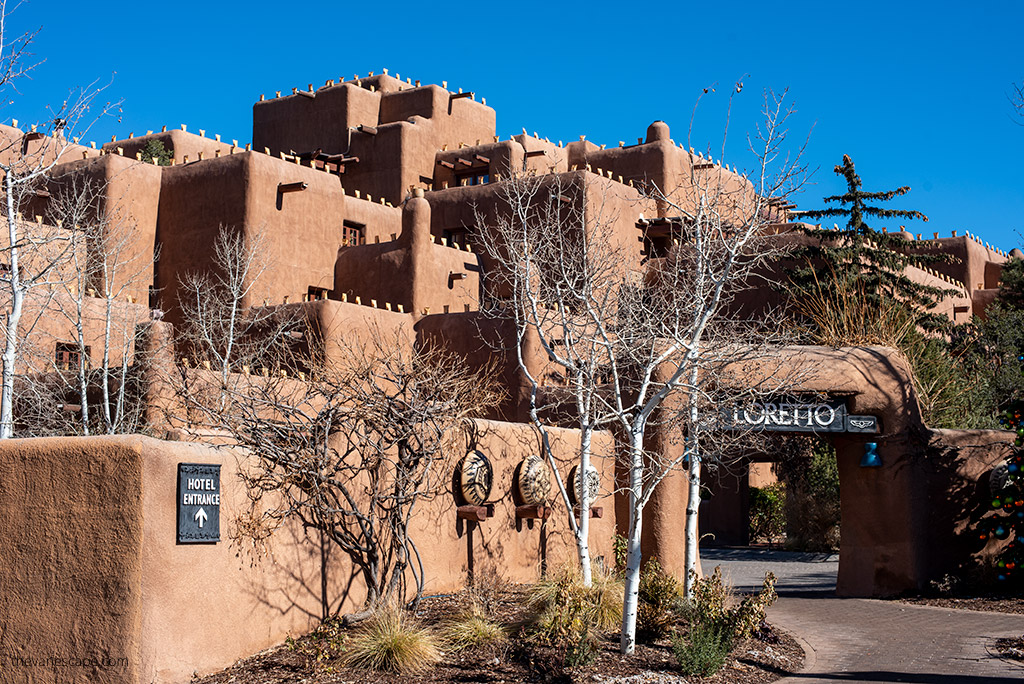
[477,173,629,586]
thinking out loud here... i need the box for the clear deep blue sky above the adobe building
[9,0,1024,250]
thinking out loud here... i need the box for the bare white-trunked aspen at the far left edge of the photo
[0,2,112,438]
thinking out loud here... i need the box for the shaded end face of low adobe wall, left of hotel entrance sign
[0,438,148,684]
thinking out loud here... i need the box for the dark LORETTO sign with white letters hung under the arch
[722,400,879,433]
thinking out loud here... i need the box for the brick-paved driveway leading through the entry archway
[701,549,1024,684]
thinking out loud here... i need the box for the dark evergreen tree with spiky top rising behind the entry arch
[790,155,948,325]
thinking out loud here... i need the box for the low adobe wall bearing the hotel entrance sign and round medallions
[0,421,615,684]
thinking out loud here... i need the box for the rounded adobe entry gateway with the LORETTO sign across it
[648,346,1014,596]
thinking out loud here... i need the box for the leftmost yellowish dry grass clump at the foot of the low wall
[342,606,441,674]
